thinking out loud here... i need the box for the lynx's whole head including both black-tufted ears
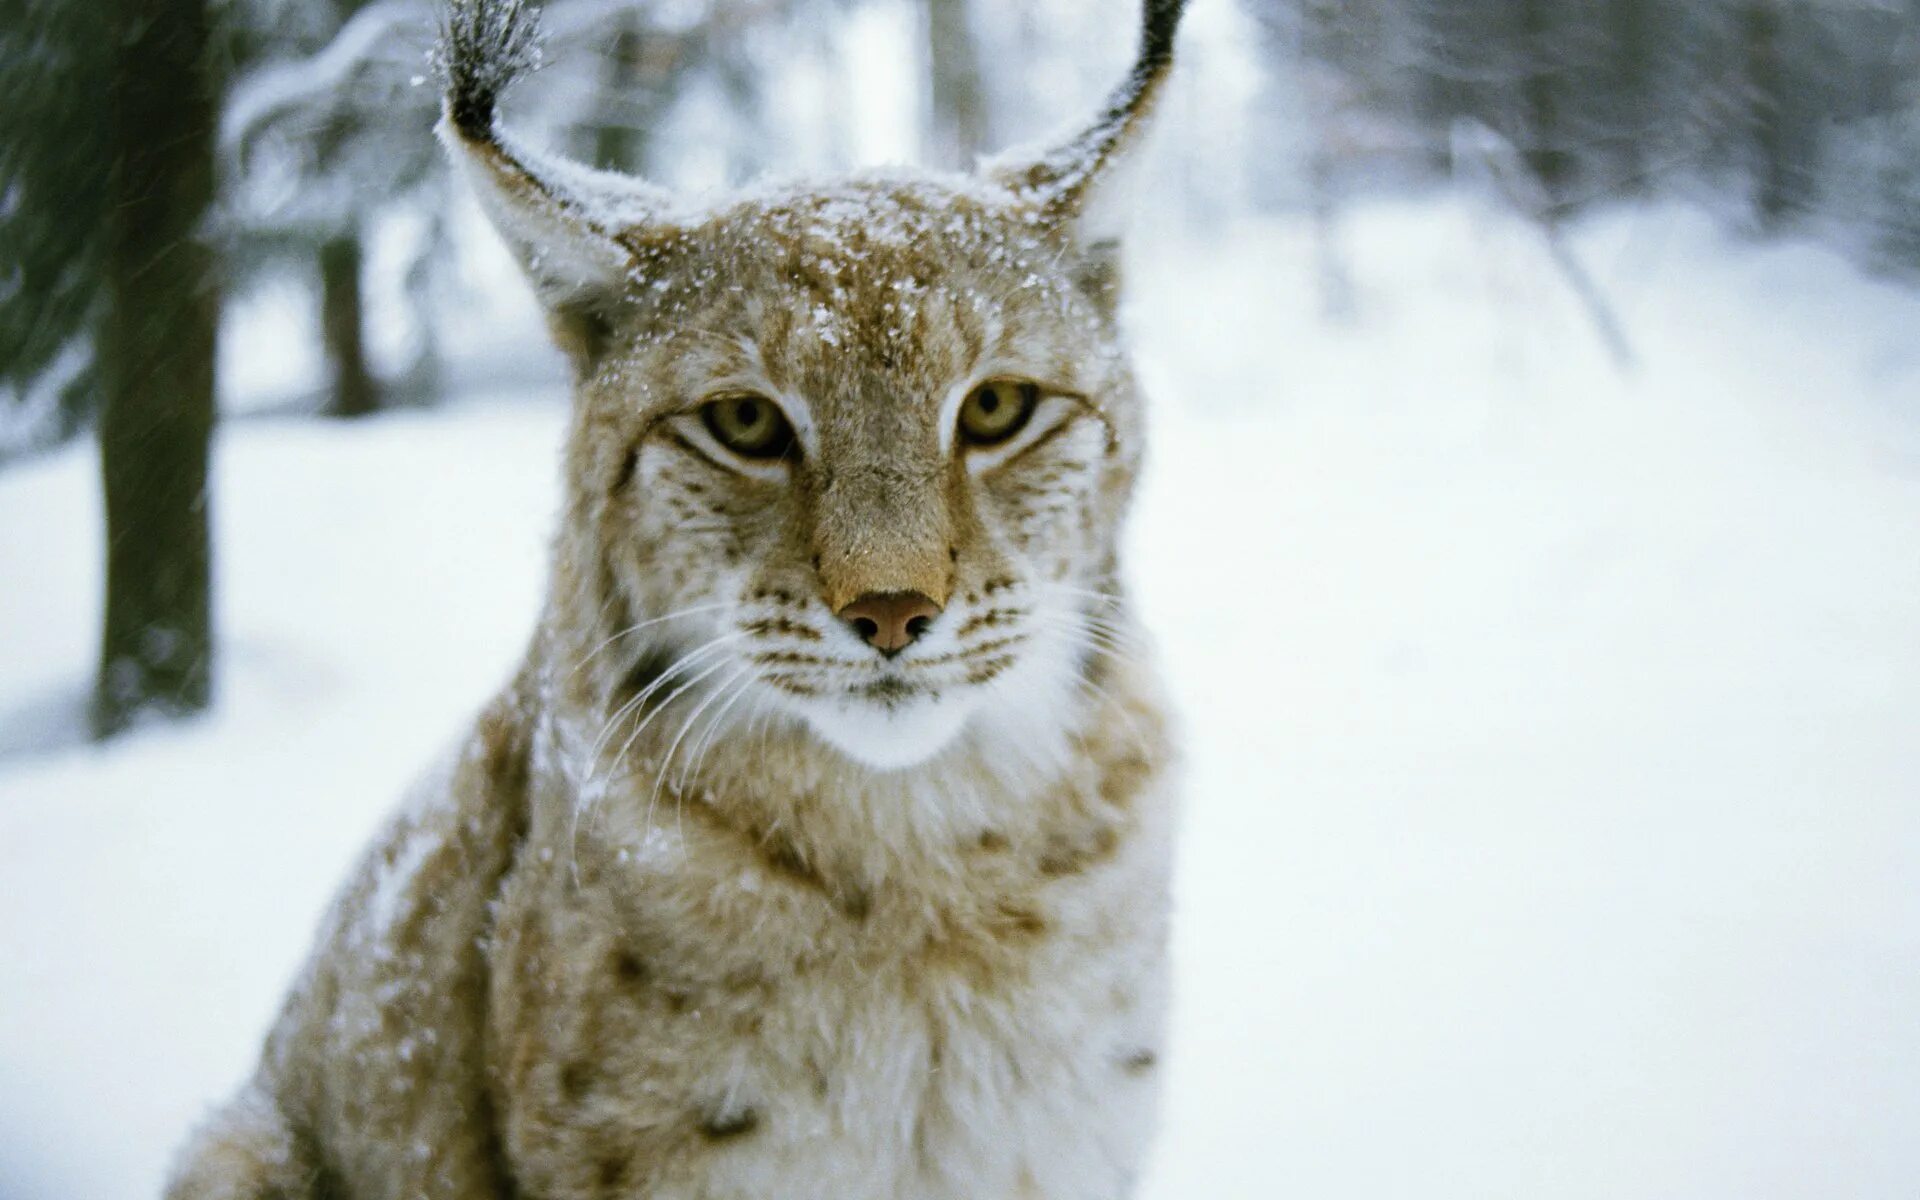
[442,0,1181,770]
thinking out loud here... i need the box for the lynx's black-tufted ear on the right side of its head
[983,0,1187,257]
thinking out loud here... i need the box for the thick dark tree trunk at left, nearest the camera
[92,0,219,737]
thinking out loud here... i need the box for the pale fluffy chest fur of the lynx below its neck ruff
[492,752,1169,1200]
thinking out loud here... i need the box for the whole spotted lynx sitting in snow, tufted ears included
[169,0,1181,1200]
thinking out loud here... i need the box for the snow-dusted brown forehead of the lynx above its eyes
[586,177,1129,472]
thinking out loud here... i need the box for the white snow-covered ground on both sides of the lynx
[0,200,1920,1200]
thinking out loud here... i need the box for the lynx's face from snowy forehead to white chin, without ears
[574,180,1139,768]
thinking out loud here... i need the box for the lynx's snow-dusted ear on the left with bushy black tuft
[440,0,664,351]
